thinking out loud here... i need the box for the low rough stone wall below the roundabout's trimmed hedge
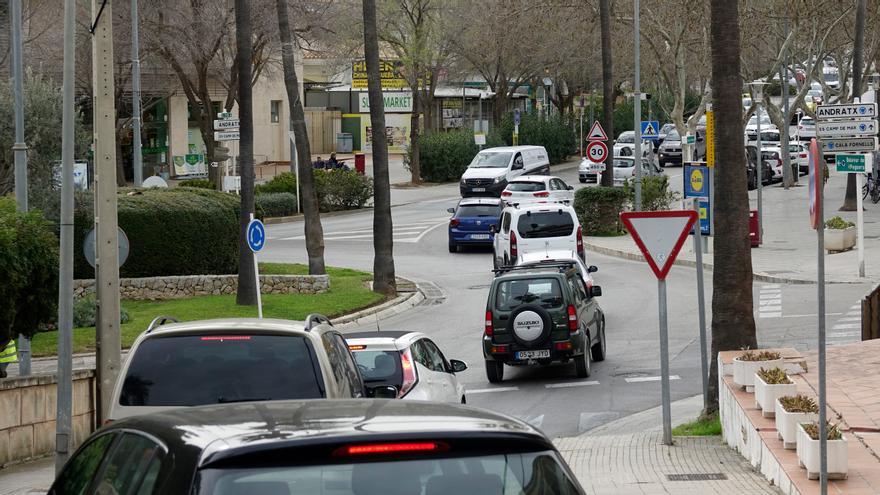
[73,275,330,300]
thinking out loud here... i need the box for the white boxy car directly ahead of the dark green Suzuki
[493,203,584,269]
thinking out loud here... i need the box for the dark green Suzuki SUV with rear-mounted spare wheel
[483,260,605,383]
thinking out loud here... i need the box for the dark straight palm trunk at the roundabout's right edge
[363,0,397,296]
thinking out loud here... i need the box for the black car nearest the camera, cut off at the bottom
[49,399,583,495]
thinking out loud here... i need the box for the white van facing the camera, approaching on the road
[459,146,550,198]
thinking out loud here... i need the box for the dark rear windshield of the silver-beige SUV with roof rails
[119,334,323,406]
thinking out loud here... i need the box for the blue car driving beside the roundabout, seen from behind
[446,198,504,253]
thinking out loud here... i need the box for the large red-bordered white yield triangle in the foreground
[620,210,697,280]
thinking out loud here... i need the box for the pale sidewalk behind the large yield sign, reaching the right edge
[585,173,880,283]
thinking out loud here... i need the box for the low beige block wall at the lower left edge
[0,370,95,467]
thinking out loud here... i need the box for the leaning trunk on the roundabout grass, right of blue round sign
[275,0,327,275]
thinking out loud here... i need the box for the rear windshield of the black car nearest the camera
[198,452,581,495]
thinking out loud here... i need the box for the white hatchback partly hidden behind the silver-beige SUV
[345,331,467,404]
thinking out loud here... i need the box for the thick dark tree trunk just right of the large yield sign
[705,0,757,413]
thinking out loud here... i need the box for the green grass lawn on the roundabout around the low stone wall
[31,263,384,356]
